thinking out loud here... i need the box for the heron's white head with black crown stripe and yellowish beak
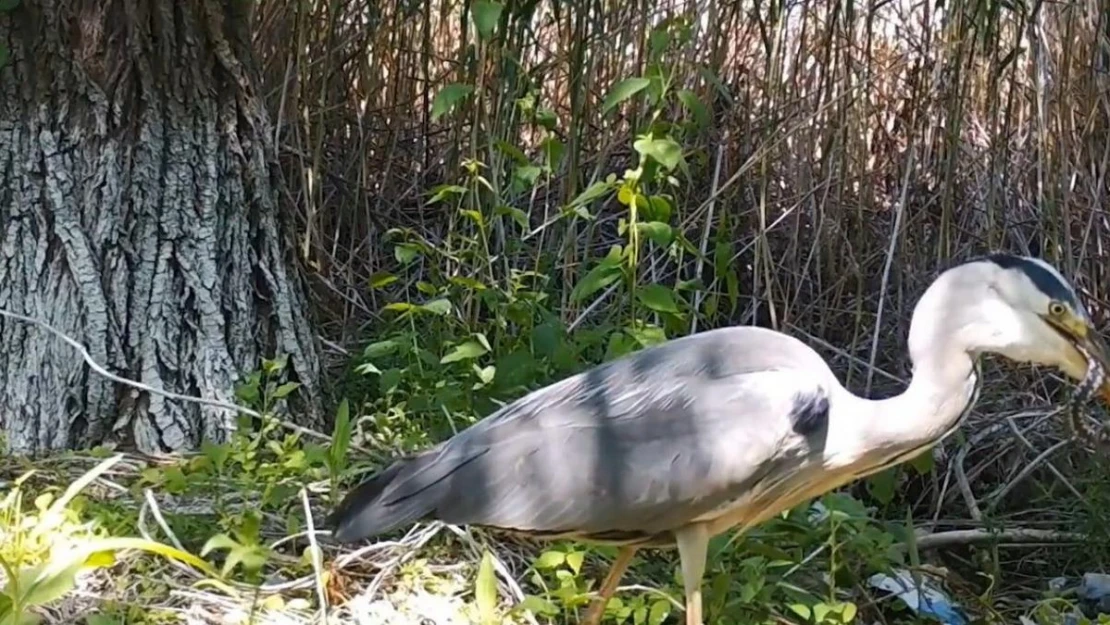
[982,254,1110,404]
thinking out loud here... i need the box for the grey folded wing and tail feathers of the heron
[333,327,835,541]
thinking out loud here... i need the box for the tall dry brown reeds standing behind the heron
[255,0,1110,386]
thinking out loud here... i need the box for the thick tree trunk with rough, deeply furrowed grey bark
[0,0,320,454]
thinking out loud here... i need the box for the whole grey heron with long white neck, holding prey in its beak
[330,253,1110,625]
